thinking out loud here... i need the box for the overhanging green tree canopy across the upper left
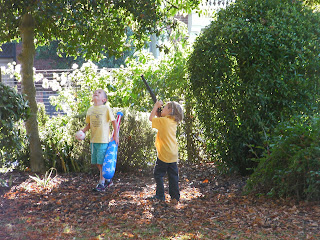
[0,0,200,59]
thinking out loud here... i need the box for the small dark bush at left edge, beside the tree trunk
[0,83,29,168]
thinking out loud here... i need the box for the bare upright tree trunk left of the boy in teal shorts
[18,14,45,172]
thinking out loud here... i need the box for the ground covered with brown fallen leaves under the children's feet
[0,164,320,240]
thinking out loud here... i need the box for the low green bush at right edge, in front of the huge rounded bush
[246,116,320,200]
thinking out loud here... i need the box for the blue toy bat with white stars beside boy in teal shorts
[102,112,123,179]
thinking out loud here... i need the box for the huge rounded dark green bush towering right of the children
[188,0,320,174]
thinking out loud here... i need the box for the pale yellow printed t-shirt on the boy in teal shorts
[86,104,115,143]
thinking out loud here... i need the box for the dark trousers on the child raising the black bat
[153,158,180,201]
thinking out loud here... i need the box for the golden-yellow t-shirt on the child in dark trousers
[152,117,178,163]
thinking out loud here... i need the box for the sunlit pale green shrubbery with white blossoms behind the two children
[16,30,207,172]
